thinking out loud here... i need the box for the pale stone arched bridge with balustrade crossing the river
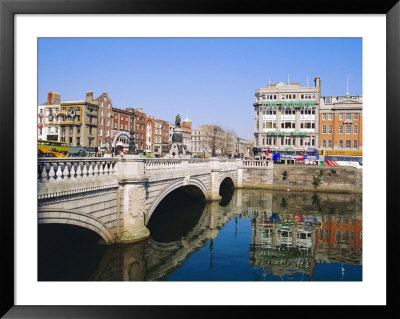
[37,155,268,244]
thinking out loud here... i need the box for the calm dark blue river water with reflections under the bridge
[38,189,362,281]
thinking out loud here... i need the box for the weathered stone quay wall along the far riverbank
[243,164,363,193]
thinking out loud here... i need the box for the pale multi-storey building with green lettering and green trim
[253,76,321,151]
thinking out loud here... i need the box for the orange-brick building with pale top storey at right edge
[318,95,363,155]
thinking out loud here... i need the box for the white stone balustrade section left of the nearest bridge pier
[38,157,118,183]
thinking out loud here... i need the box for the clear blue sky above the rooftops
[38,38,362,139]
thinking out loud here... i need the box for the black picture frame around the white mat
[0,0,400,318]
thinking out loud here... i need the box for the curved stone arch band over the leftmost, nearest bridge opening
[38,209,114,244]
